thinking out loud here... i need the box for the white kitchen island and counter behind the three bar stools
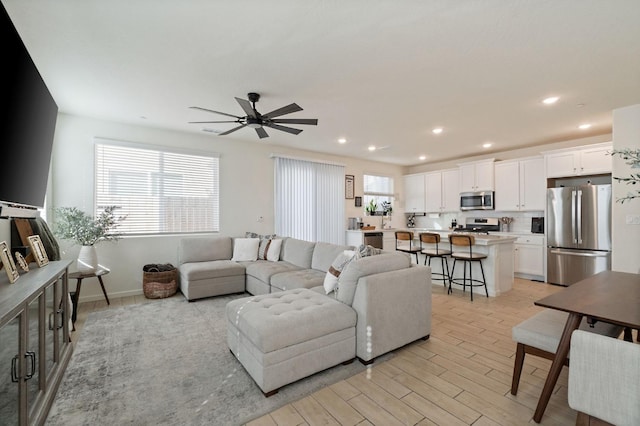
[347,228,518,297]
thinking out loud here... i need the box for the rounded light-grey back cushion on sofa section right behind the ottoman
[336,253,411,306]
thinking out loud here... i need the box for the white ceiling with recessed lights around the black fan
[2,0,640,165]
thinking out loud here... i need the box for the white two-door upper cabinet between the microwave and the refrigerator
[495,157,546,211]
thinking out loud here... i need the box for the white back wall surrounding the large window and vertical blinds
[49,114,404,300]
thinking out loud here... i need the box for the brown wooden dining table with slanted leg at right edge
[533,271,640,423]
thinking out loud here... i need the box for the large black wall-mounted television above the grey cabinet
[0,5,58,207]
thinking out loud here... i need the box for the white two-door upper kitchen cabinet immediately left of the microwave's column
[425,169,460,213]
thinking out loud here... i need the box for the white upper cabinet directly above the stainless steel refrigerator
[545,142,613,178]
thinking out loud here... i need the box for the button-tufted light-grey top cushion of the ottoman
[226,288,356,353]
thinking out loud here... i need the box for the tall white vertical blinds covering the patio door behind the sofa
[275,157,345,244]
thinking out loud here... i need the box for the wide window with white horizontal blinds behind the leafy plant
[95,140,220,235]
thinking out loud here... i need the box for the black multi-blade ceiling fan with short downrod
[189,92,318,139]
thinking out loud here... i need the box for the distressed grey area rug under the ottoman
[46,294,389,426]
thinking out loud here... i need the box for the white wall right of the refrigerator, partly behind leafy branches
[611,104,640,273]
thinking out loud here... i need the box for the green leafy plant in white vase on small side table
[54,206,125,271]
